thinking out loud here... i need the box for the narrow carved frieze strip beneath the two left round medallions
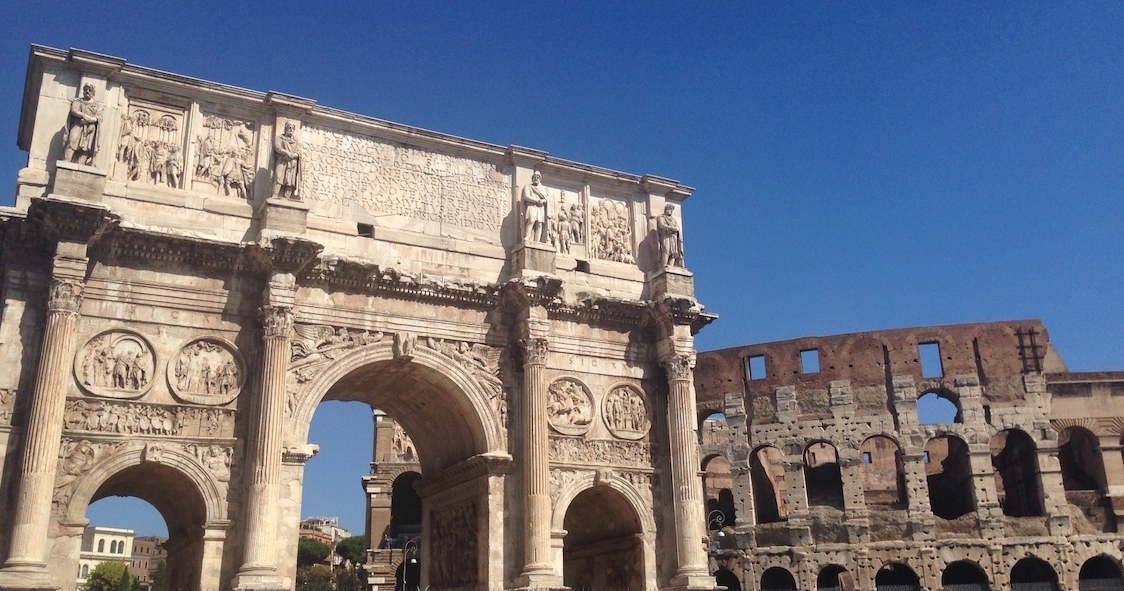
[63,399,234,438]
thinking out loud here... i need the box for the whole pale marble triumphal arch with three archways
[0,46,714,590]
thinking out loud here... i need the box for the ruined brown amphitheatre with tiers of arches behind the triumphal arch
[696,320,1124,591]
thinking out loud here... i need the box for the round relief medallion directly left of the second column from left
[167,338,246,404]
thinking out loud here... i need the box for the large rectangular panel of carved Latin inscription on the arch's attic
[300,126,511,235]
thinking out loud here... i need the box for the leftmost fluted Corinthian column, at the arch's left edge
[4,279,82,578]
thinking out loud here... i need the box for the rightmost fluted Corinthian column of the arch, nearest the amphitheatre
[660,352,715,588]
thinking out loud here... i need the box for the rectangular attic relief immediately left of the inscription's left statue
[191,113,257,200]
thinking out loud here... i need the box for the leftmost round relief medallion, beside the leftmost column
[74,330,156,398]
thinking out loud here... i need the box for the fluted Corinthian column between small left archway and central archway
[236,306,294,589]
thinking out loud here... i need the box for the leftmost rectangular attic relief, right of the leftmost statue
[112,99,184,189]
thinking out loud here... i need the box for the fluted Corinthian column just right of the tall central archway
[516,338,562,588]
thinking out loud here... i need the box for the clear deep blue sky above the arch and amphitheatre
[0,0,1124,541]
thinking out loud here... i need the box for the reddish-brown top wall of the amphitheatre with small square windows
[695,320,1066,410]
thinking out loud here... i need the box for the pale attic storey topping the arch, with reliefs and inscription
[16,46,692,299]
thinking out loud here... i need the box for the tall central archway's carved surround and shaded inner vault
[285,337,511,587]
